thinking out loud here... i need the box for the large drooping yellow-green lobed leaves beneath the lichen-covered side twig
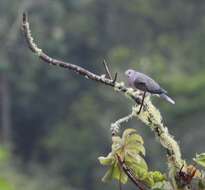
[98,129,166,187]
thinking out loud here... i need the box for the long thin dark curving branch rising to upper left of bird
[22,13,141,104]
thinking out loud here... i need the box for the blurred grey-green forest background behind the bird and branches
[0,0,205,190]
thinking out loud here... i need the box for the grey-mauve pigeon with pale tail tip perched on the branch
[125,69,175,114]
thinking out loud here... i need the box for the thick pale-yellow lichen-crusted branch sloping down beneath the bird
[111,92,184,174]
